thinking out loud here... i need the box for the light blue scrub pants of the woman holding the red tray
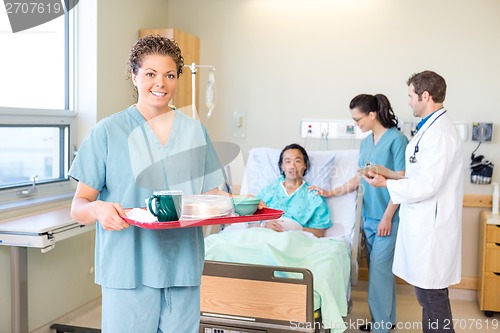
[101,286,200,333]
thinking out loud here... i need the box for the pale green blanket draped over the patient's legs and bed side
[205,228,350,332]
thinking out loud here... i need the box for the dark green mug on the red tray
[147,191,182,222]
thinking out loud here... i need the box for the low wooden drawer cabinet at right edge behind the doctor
[477,211,500,317]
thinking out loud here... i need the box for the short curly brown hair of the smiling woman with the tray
[128,35,184,77]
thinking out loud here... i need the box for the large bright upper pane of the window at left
[0,7,71,110]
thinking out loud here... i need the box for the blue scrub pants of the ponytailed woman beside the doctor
[363,218,399,333]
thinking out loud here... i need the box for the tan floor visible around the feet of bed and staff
[32,281,500,333]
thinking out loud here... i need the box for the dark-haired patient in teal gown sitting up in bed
[250,144,332,237]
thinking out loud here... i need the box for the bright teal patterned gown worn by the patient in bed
[257,177,332,229]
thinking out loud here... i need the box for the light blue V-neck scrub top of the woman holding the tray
[69,106,225,288]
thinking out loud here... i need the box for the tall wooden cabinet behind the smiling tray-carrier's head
[139,28,200,116]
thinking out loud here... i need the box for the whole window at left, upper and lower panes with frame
[0,8,76,204]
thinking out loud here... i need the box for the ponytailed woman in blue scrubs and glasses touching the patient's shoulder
[310,94,408,333]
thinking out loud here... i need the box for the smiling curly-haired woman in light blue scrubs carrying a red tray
[69,35,228,333]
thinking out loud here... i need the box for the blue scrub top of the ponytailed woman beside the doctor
[358,127,408,222]
